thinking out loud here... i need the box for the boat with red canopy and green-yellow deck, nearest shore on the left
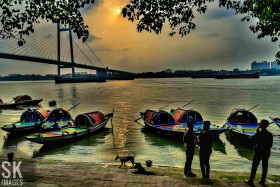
[25,111,113,145]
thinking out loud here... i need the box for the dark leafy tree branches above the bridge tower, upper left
[0,0,94,46]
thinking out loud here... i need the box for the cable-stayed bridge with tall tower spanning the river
[0,24,133,76]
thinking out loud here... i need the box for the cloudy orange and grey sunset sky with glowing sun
[0,0,279,75]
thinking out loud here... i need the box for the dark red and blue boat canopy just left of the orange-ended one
[144,110,175,125]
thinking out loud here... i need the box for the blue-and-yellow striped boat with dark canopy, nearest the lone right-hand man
[224,108,258,146]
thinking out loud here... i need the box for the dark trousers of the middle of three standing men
[199,150,212,178]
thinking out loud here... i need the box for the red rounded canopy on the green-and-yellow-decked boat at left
[74,111,105,128]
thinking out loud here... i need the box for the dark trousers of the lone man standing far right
[250,151,270,181]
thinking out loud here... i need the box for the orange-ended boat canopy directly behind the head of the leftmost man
[172,108,203,123]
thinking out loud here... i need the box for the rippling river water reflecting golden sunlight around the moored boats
[0,77,280,174]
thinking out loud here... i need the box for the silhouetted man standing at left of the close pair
[183,122,196,177]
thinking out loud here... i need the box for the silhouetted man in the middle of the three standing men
[198,121,212,179]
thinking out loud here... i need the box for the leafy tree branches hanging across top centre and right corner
[122,0,280,63]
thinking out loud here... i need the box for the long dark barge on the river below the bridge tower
[54,76,107,84]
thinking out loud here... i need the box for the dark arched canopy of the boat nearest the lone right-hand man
[227,108,258,123]
